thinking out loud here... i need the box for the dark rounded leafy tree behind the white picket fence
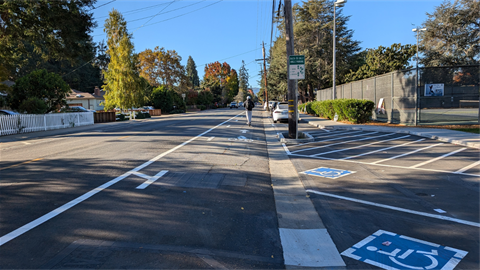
[8,69,70,113]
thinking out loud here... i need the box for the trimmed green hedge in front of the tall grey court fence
[298,99,375,124]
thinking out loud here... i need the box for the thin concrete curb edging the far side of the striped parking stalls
[302,119,480,149]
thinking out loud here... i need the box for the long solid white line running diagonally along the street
[0,113,242,246]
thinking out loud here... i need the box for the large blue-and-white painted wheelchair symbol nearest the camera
[342,230,468,270]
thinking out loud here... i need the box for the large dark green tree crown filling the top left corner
[0,0,96,79]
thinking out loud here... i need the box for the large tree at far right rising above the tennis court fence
[420,0,480,66]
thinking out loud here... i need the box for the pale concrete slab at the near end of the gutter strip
[279,228,345,267]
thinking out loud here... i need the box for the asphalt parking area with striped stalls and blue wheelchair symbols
[277,124,480,270]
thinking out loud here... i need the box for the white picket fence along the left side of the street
[0,112,93,136]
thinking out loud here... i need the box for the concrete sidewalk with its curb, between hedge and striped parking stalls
[300,114,480,149]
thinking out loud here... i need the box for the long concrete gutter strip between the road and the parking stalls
[263,112,347,270]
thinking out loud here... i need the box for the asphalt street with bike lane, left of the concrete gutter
[0,109,284,270]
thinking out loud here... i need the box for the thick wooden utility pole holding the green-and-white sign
[284,0,298,139]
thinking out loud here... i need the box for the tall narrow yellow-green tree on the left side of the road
[103,9,143,110]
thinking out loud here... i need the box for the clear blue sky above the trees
[92,0,443,87]
